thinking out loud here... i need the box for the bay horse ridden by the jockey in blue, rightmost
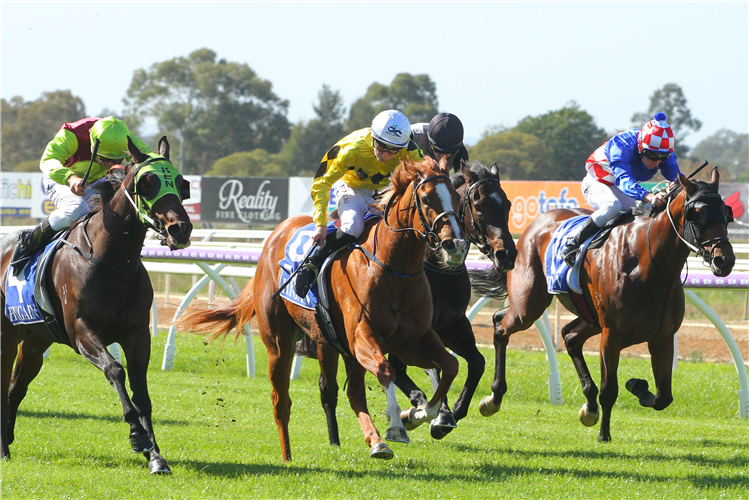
[479,168,735,441]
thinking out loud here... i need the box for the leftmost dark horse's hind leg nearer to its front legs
[7,336,52,445]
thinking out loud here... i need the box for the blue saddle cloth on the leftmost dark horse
[5,239,58,325]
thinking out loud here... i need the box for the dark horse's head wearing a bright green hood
[122,137,192,250]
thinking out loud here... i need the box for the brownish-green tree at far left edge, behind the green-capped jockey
[0,90,86,171]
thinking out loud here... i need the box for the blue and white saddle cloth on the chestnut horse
[278,213,379,311]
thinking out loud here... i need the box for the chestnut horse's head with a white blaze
[382,158,469,268]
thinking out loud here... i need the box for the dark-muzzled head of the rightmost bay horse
[679,167,736,276]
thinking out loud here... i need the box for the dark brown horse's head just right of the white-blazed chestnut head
[453,161,518,272]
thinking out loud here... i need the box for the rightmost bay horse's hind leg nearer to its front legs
[562,318,599,427]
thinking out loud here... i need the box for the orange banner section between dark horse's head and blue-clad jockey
[502,181,590,234]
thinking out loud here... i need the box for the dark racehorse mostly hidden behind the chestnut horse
[298,161,517,445]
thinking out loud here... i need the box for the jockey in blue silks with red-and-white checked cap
[560,113,680,267]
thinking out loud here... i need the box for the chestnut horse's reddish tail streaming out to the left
[175,279,255,342]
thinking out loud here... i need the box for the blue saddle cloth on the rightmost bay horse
[544,215,594,295]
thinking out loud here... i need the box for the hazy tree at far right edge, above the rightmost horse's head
[691,129,749,182]
